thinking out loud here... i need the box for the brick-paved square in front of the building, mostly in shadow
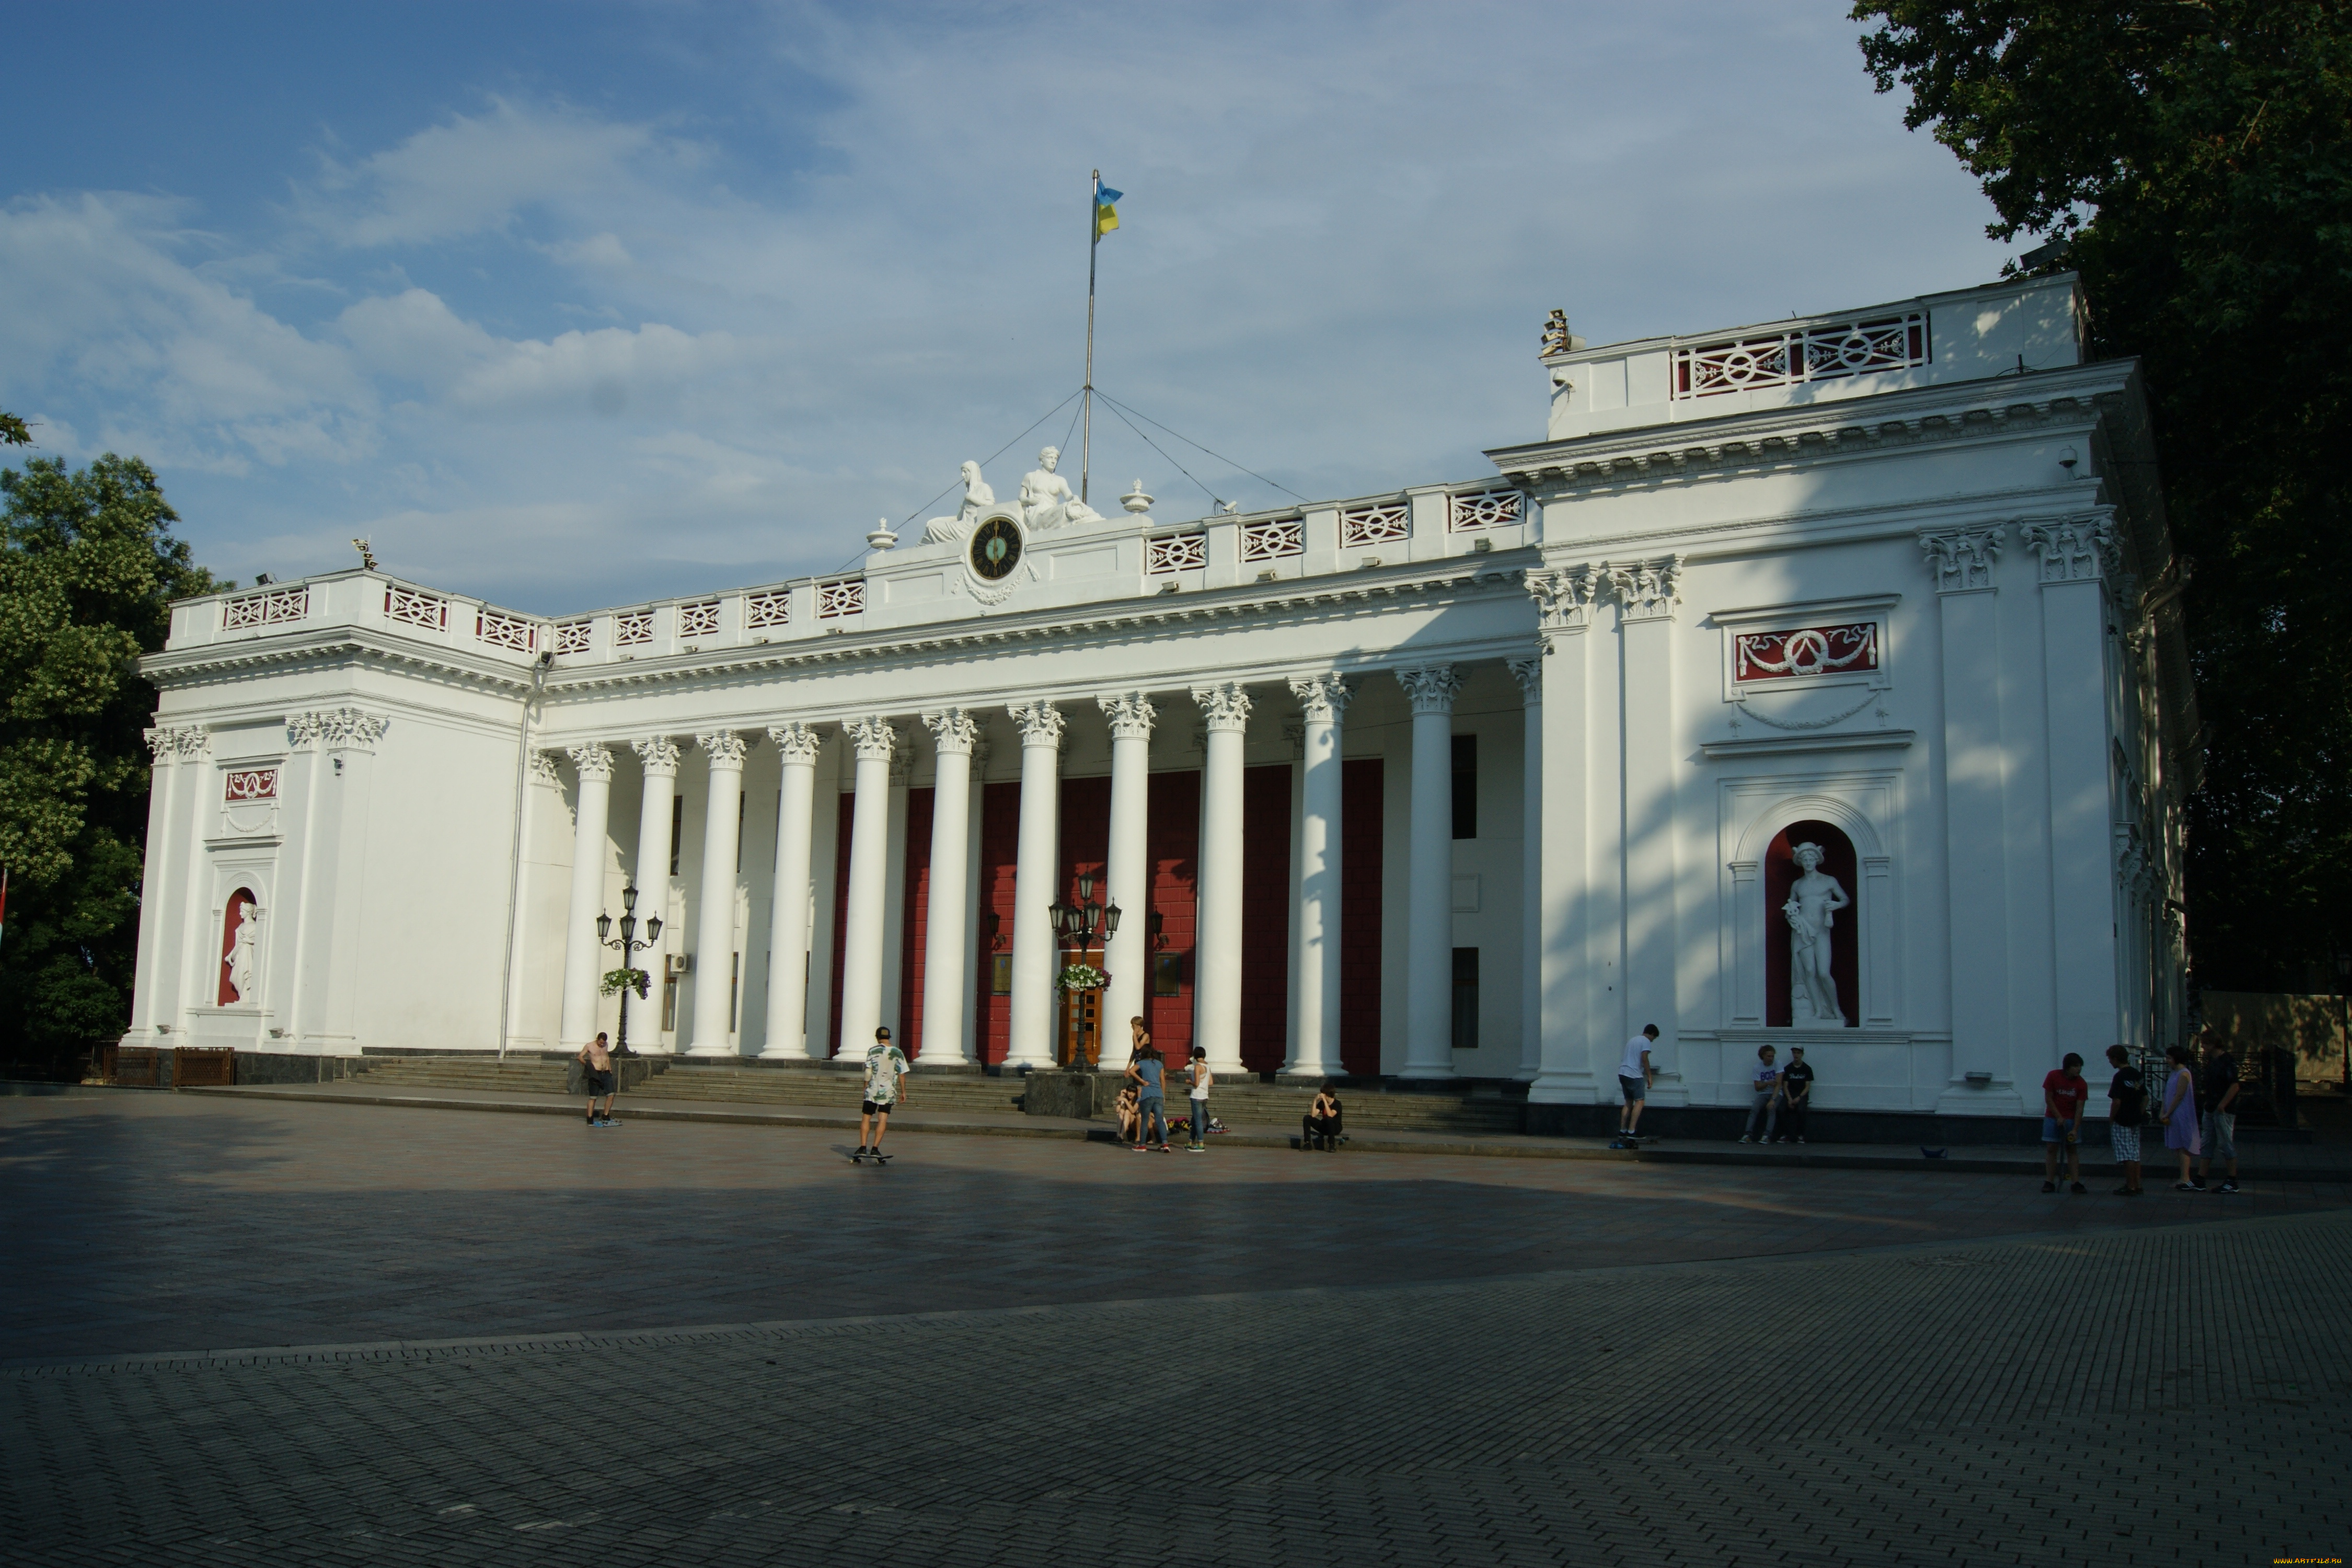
[0,1096,2352,1563]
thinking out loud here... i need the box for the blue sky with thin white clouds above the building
[0,0,2013,614]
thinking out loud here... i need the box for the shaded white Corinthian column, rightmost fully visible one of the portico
[1397,665,1461,1079]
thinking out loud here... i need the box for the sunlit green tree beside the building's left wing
[0,454,216,1065]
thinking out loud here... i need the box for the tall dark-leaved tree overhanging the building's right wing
[1853,0,2352,990]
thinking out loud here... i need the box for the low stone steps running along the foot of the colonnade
[343,1055,1524,1135]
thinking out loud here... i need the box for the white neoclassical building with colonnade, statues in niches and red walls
[125,278,2197,1114]
